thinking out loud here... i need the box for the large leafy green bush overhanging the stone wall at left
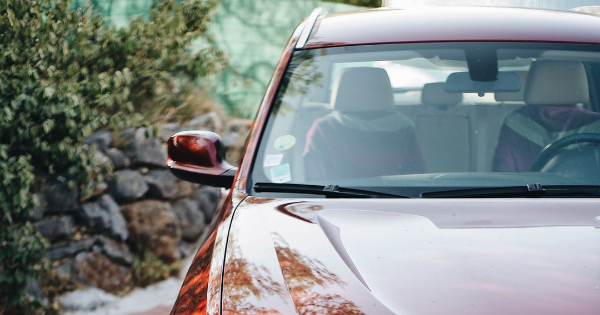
[0,0,225,314]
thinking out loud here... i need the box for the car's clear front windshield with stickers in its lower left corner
[250,43,600,196]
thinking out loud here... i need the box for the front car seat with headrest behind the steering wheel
[493,60,600,172]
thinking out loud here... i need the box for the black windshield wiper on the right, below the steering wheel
[421,184,600,198]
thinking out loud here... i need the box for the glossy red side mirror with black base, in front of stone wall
[167,130,237,188]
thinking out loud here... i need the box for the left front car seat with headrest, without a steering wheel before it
[303,67,425,180]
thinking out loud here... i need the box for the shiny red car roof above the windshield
[304,7,600,49]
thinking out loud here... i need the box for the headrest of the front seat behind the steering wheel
[525,60,590,105]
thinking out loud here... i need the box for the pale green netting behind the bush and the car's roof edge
[72,0,358,117]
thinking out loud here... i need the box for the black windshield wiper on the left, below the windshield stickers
[254,183,410,198]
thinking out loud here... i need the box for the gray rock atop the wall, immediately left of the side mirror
[120,128,167,168]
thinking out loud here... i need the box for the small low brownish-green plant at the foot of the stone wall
[132,250,181,287]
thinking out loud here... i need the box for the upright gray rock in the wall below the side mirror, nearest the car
[173,199,206,242]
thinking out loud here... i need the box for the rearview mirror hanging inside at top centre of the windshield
[444,71,521,95]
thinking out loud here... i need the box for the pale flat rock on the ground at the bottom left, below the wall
[58,288,119,311]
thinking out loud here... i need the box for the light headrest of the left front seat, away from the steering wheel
[331,67,394,111]
